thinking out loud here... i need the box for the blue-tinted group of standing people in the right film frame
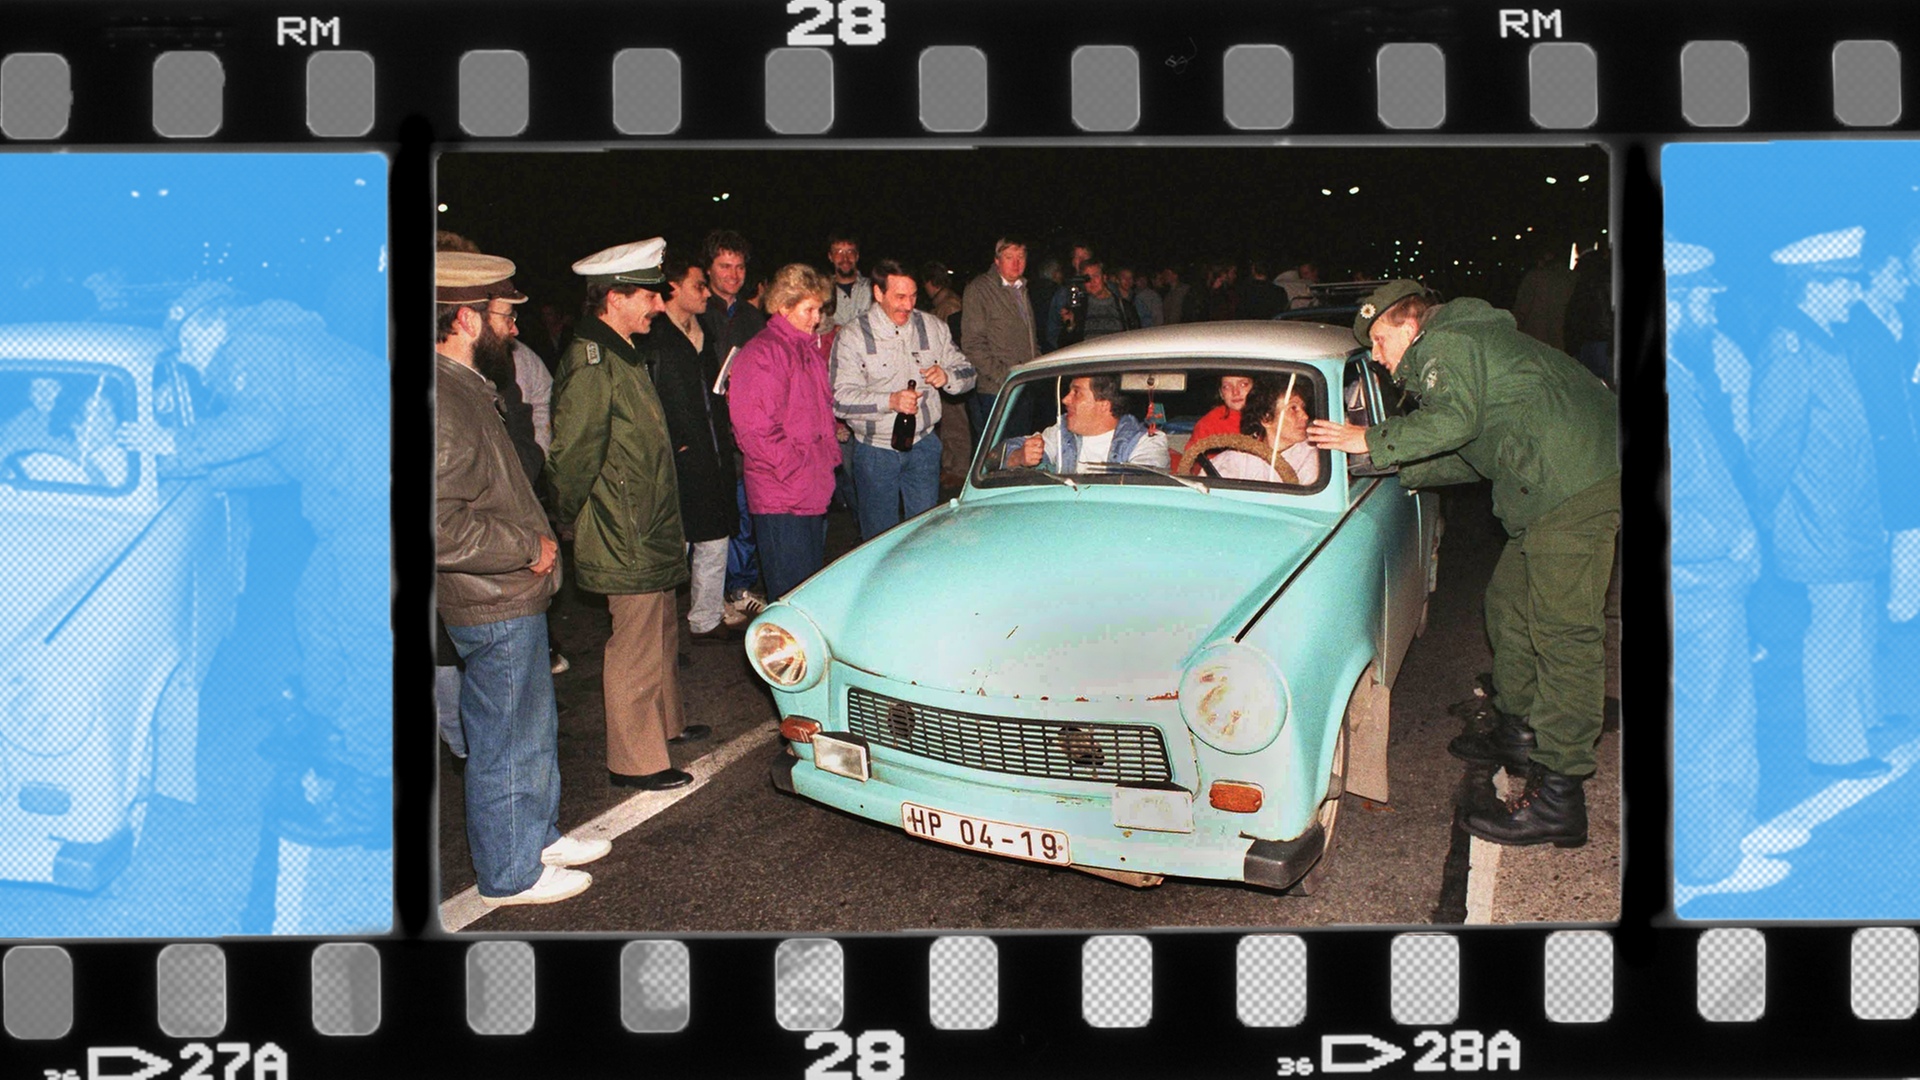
[1665,227,1920,892]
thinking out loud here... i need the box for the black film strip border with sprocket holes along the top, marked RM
[0,0,1905,144]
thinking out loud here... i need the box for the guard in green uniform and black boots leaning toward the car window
[1308,281,1620,847]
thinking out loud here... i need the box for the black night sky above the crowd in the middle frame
[438,146,1609,306]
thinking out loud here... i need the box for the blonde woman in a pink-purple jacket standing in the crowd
[728,263,841,600]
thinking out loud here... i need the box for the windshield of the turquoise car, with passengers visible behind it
[973,359,1329,494]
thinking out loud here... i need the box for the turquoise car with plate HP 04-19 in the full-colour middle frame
[747,321,1442,892]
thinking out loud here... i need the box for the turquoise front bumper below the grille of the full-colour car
[772,746,1327,888]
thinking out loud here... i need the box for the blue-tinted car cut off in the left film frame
[0,323,248,892]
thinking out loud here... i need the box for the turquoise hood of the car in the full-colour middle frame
[789,488,1331,700]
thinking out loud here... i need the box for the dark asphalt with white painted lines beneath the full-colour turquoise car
[438,478,1620,934]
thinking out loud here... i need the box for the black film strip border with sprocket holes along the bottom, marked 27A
[0,926,1920,1076]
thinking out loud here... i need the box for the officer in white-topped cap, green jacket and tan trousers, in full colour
[547,236,712,792]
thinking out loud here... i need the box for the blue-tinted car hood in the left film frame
[0,513,148,655]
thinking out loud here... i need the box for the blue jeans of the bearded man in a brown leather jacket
[447,615,561,896]
